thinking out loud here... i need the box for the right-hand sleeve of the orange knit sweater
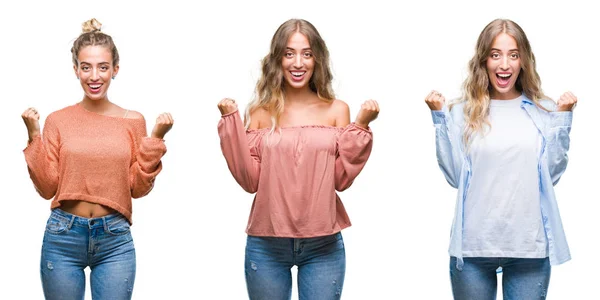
[129,119,167,198]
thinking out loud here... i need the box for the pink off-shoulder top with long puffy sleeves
[218,111,373,238]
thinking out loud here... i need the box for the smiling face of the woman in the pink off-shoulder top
[281,32,315,89]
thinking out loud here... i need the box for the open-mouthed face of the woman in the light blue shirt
[486,33,521,100]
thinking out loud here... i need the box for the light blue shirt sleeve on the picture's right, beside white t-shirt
[547,111,573,185]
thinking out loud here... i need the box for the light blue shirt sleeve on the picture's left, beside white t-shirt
[431,106,463,188]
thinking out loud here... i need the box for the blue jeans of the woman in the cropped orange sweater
[40,208,135,300]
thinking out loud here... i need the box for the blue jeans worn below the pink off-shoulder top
[245,232,346,300]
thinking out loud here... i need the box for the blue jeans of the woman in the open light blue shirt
[450,257,550,300]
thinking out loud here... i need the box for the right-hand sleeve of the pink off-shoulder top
[335,123,373,192]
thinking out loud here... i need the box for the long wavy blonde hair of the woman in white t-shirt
[450,19,549,148]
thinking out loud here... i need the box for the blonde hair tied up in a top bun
[71,19,119,66]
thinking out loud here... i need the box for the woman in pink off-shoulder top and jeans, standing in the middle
[218,19,379,300]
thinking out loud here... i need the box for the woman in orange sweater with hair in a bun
[22,19,173,300]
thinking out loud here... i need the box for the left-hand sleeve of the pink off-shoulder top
[218,111,263,193]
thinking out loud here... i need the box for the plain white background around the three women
[0,0,600,299]
